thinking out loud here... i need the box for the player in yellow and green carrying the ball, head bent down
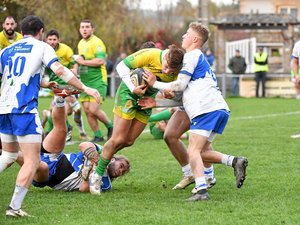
[90,45,184,194]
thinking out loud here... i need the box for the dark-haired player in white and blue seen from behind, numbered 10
[0,16,100,217]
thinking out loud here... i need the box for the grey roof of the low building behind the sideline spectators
[210,13,300,29]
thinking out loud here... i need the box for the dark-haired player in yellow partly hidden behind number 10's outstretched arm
[43,30,88,140]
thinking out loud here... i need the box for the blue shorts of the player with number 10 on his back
[0,113,43,136]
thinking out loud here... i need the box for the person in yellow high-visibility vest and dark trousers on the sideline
[254,47,269,98]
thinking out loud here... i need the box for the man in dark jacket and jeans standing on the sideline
[228,49,247,96]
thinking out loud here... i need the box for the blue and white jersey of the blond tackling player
[179,49,229,120]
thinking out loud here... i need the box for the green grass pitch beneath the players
[0,98,300,225]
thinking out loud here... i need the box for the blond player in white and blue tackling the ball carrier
[144,22,248,201]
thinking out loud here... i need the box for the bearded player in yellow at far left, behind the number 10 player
[0,16,23,50]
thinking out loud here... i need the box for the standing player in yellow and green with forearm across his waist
[74,20,113,142]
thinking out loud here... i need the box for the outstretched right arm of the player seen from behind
[50,61,100,103]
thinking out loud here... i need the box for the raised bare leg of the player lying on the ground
[43,96,67,153]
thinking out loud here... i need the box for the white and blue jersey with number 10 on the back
[0,37,58,114]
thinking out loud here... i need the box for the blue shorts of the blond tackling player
[190,109,230,134]
